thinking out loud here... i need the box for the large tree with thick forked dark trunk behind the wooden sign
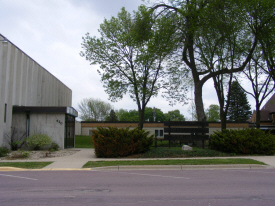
[142,0,262,121]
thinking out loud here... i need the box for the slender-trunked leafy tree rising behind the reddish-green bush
[81,6,182,129]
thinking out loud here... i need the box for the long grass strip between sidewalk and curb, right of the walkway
[83,158,265,168]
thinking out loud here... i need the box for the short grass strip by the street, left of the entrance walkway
[0,162,53,169]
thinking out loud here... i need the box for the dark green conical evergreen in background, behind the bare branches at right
[227,81,252,122]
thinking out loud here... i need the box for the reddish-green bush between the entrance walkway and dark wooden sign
[92,127,154,157]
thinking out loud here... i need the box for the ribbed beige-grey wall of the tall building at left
[0,35,72,146]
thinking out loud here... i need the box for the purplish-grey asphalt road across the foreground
[0,169,275,206]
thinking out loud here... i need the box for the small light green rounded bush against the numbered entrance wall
[26,133,52,150]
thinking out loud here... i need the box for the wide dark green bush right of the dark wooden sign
[210,128,275,155]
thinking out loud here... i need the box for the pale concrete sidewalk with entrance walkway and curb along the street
[2,148,275,170]
